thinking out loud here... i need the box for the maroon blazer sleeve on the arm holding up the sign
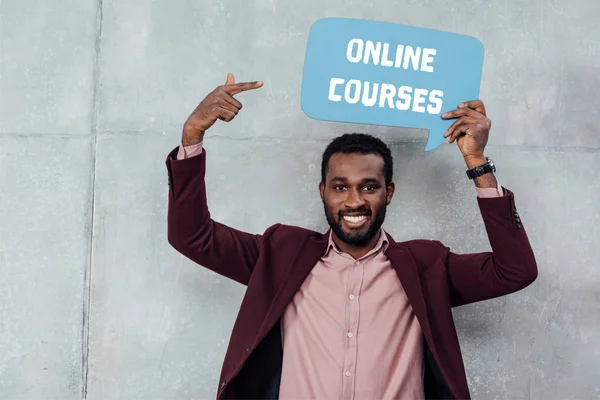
[436,188,538,307]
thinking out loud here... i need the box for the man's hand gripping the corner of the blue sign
[442,100,492,168]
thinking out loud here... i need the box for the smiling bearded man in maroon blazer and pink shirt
[166,74,537,399]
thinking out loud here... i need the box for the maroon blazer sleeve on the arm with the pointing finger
[166,145,276,285]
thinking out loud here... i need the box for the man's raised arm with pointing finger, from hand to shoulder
[166,74,270,285]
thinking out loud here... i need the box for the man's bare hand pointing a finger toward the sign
[182,74,263,146]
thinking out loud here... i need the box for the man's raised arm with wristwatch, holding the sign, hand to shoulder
[436,100,538,306]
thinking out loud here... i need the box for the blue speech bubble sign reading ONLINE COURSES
[302,18,484,151]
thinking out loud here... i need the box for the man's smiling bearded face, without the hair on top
[319,153,394,246]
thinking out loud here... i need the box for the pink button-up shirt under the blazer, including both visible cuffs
[177,143,502,400]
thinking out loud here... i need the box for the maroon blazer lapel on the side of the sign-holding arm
[385,234,433,346]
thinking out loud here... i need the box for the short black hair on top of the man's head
[321,133,394,186]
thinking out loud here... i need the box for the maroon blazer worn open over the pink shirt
[166,148,537,399]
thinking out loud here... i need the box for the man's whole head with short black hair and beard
[319,133,394,247]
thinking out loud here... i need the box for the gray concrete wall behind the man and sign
[0,0,600,400]
